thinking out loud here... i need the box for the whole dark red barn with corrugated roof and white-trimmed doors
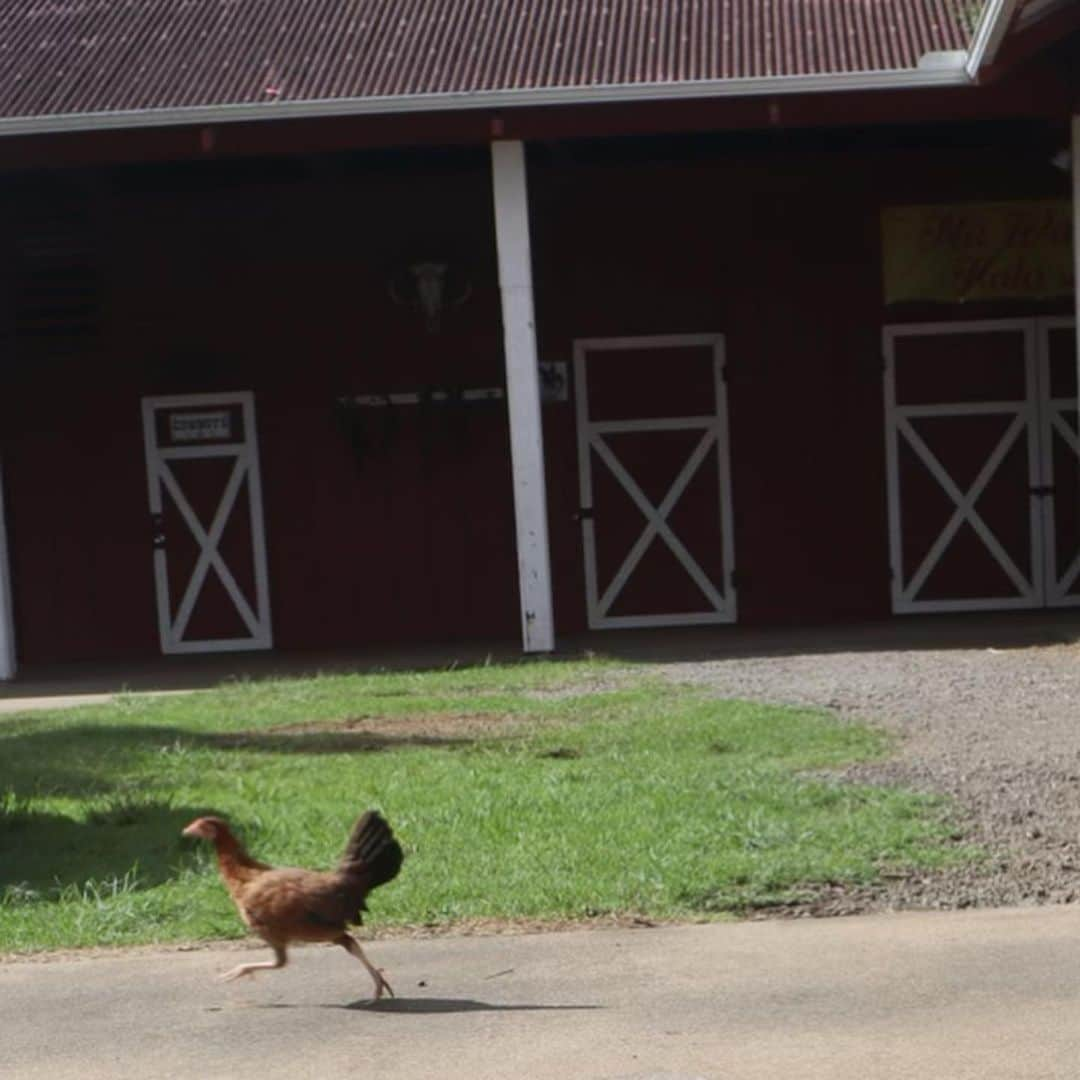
[0,0,1080,677]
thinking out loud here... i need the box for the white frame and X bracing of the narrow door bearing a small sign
[143,391,273,653]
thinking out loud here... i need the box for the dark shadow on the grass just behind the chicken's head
[0,796,205,903]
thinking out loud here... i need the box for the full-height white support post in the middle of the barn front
[491,140,555,652]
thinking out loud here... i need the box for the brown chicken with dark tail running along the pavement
[183,810,405,1001]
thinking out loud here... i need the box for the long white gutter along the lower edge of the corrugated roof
[0,56,972,136]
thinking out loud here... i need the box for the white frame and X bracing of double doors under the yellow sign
[883,319,1080,613]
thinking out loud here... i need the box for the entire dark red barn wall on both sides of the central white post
[0,124,1065,663]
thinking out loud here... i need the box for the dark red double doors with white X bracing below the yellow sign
[885,319,1080,612]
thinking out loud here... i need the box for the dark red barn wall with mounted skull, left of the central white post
[3,149,517,663]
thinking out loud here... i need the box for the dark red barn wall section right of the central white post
[532,125,1070,629]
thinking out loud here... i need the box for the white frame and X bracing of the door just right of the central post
[573,334,735,630]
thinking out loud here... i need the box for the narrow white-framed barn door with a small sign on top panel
[143,392,272,652]
